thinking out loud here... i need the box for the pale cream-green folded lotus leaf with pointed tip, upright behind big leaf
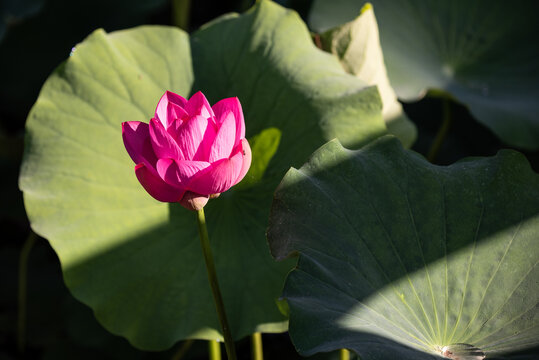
[320,5,417,148]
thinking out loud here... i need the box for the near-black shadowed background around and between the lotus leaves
[0,0,539,360]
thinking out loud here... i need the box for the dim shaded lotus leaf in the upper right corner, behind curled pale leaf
[310,0,539,150]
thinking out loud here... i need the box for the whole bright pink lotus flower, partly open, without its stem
[122,91,251,210]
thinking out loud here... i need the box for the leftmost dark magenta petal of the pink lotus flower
[122,121,157,167]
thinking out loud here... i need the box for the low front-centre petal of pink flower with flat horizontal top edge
[156,159,210,188]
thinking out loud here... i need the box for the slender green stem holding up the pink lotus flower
[197,209,237,360]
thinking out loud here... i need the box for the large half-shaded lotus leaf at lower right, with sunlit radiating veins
[268,136,539,360]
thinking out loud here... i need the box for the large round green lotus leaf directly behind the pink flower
[20,1,385,349]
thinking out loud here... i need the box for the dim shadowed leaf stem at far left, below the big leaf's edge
[17,230,37,354]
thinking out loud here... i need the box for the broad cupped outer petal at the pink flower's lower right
[188,151,244,195]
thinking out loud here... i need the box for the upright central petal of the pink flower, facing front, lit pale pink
[176,115,216,161]
